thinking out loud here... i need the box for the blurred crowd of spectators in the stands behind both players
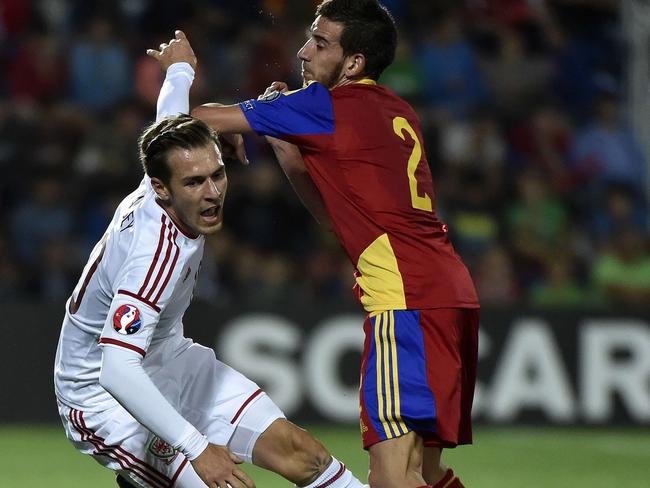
[0,0,650,307]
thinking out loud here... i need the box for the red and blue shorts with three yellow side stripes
[360,308,479,449]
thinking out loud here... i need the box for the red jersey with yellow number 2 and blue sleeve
[240,80,478,312]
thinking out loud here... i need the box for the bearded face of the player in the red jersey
[298,16,345,88]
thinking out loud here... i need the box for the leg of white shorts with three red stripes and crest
[59,404,188,488]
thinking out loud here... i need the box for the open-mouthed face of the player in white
[163,144,228,234]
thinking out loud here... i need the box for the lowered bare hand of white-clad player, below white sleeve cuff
[192,444,255,488]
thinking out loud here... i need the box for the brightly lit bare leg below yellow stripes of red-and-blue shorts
[368,432,425,488]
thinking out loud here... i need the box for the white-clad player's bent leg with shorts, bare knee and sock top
[175,344,364,488]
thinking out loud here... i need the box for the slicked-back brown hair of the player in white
[138,115,221,184]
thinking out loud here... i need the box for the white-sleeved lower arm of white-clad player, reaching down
[99,346,208,460]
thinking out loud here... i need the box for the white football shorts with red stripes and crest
[59,344,284,488]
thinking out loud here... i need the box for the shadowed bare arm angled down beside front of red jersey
[267,137,332,230]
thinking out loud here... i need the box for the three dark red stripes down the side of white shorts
[68,409,171,488]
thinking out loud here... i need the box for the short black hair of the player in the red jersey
[316,0,397,80]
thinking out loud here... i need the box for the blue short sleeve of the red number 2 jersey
[239,82,334,143]
